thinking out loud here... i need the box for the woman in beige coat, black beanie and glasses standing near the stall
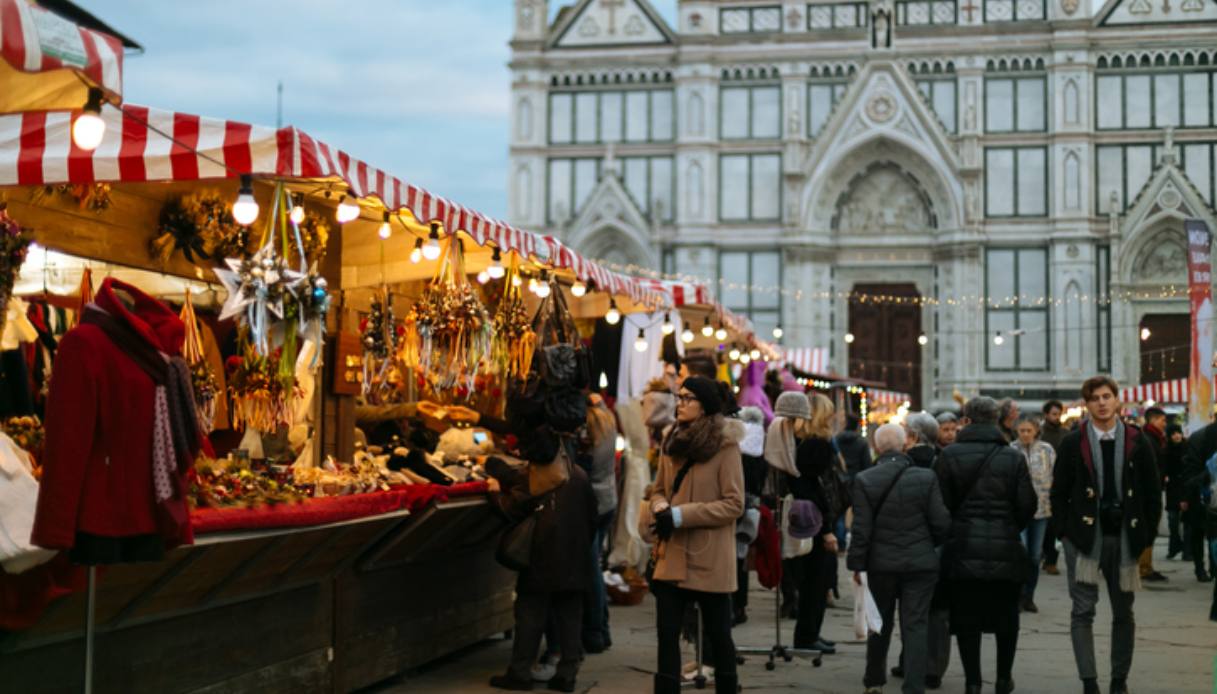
[640,376,744,694]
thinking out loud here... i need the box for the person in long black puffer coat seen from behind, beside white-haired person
[937,397,1036,694]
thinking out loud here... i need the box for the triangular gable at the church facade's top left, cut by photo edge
[550,0,675,49]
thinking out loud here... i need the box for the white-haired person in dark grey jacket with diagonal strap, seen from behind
[847,424,950,694]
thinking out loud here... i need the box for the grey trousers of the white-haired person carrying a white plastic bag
[862,571,934,694]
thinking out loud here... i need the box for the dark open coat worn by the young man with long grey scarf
[1051,422,1162,556]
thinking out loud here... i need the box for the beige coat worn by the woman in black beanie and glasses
[638,419,745,593]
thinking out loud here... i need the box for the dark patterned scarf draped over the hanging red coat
[80,303,200,502]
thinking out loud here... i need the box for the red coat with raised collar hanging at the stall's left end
[32,280,194,549]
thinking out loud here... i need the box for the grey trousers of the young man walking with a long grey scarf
[1062,535,1137,679]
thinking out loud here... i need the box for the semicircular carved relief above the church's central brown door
[832,162,937,234]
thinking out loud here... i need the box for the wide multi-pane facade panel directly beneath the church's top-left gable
[549,89,675,145]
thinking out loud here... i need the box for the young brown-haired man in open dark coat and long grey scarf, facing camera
[1051,376,1162,694]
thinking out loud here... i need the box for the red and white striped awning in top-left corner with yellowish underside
[0,0,123,113]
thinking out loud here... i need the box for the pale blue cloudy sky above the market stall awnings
[78,0,675,217]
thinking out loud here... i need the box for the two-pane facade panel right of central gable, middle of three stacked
[985,147,1048,217]
